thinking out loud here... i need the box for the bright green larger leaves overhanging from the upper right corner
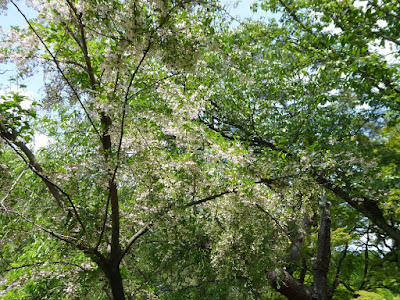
[264,1,398,113]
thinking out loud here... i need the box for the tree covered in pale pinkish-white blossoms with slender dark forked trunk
[0,0,225,299]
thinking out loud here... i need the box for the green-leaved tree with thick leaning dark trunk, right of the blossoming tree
[195,1,400,299]
